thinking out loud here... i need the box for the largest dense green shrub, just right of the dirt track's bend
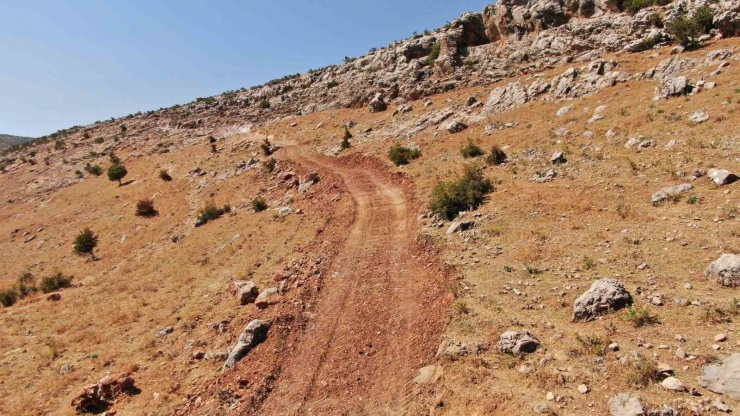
[430,166,493,220]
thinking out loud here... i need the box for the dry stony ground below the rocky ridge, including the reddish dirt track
[0,26,740,415]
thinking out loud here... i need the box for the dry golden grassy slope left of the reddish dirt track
[0,133,351,414]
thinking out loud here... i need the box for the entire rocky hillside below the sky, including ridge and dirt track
[0,1,740,415]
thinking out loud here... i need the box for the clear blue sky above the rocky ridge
[0,0,492,137]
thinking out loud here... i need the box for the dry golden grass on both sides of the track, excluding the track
[0,36,740,415]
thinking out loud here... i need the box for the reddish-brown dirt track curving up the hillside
[258,148,444,415]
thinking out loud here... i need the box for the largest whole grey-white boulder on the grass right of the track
[573,279,632,321]
